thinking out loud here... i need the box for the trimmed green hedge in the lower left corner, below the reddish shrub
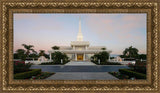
[14,69,41,79]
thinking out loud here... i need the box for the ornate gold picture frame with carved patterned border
[0,0,160,93]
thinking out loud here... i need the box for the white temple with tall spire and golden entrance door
[48,19,111,61]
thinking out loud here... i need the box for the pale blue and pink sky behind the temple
[14,13,147,55]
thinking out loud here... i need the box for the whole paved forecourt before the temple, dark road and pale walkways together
[31,62,128,80]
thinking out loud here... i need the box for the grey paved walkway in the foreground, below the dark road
[46,72,118,80]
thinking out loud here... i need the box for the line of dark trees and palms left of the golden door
[14,44,69,63]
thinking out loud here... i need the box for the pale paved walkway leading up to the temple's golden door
[65,61,96,66]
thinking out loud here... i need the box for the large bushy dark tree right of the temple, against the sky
[123,46,138,58]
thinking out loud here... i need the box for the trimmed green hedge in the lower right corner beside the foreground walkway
[119,69,146,79]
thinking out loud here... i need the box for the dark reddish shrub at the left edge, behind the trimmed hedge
[14,61,32,73]
